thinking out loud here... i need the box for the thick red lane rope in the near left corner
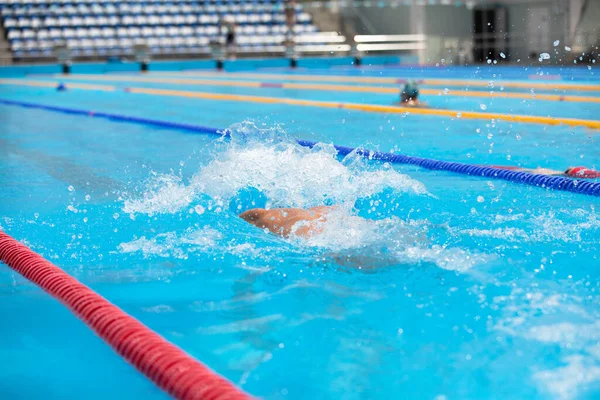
[0,231,251,400]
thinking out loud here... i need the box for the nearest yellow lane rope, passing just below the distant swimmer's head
[0,79,600,129]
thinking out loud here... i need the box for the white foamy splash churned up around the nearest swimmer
[120,122,483,271]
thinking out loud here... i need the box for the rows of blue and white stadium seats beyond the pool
[0,0,324,55]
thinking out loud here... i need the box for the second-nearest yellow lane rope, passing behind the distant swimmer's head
[50,74,600,103]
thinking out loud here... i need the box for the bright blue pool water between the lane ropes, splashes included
[0,63,600,399]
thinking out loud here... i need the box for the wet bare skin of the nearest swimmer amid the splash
[240,206,335,238]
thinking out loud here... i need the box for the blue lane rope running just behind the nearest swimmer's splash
[0,99,600,196]
